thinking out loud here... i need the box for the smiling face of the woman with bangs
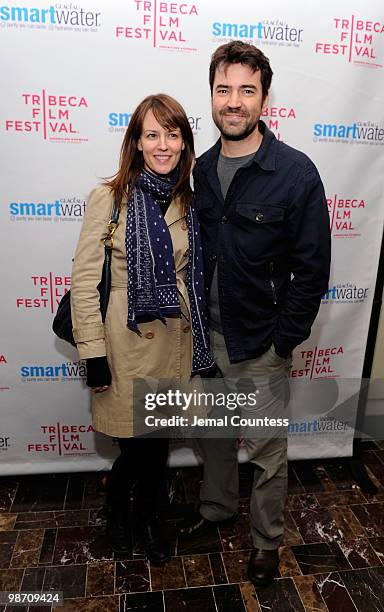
[137,110,184,174]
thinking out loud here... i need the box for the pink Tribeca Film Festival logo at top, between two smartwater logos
[115,0,199,52]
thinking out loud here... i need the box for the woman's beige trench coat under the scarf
[71,186,192,437]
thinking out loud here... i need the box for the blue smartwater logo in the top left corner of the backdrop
[0,2,101,32]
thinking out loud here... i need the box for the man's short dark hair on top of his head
[209,40,273,99]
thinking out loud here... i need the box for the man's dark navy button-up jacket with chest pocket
[193,121,331,363]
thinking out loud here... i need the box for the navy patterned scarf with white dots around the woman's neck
[125,170,215,374]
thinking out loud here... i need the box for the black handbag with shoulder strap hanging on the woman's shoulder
[52,202,120,346]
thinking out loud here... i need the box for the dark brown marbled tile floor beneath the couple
[0,442,384,612]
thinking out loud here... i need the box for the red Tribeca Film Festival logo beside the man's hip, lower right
[291,346,344,380]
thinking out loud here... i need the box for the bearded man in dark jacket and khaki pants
[180,41,330,586]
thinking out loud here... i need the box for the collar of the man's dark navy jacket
[198,119,277,173]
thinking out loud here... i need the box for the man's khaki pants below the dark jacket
[196,331,292,549]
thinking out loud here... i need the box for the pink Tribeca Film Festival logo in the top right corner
[315,15,384,68]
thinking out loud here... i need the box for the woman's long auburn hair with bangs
[105,94,195,214]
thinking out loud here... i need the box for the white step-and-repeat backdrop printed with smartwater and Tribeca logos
[0,0,384,474]
